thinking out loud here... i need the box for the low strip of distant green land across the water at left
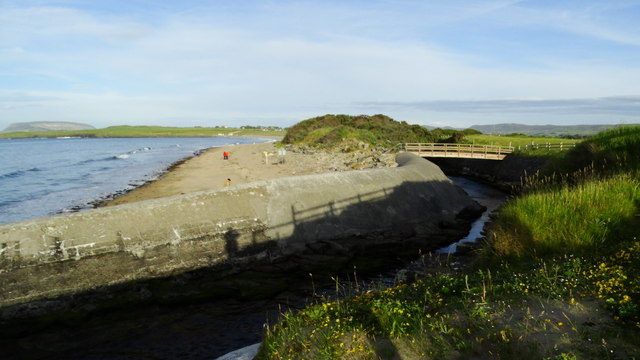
[0,125,286,139]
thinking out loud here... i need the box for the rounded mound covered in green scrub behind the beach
[282,114,438,147]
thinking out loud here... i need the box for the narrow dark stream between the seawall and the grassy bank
[0,177,507,360]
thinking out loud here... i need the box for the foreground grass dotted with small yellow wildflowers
[257,241,640,359]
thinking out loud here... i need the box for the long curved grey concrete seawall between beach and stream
[0,154,481,318]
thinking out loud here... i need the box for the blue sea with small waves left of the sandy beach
[0,137,268,224]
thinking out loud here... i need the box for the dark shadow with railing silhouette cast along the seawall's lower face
[0,176,482,358]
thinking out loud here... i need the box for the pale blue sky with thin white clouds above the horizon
[0,0,640,130]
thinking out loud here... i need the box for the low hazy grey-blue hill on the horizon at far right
[471,124,636,136]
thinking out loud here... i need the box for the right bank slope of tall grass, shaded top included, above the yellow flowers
[487,127,640,258]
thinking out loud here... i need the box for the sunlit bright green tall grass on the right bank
[488,174,640,257]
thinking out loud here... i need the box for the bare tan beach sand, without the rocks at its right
[103,142,328,206]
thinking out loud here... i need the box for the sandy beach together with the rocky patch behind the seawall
[99,141,396,207]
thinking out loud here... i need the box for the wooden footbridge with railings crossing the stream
[404,143,514,160]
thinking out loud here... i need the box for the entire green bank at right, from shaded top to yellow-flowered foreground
[257,127,640,360]
